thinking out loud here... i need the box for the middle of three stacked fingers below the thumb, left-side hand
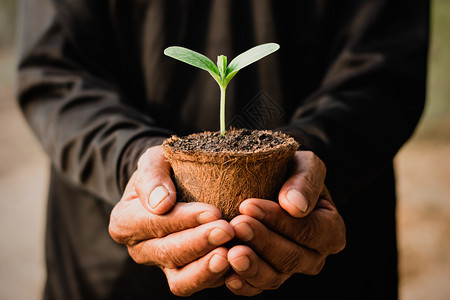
[128,220,234,269]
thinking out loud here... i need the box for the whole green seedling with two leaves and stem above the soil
[164,43,280,136]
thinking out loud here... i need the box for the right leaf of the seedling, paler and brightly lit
[224,43,280,86]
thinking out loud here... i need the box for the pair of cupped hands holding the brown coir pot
[109,146,345,296]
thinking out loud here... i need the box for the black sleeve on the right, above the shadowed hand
[283,0,429,206]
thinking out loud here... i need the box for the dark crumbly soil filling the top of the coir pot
[172,129,287,152]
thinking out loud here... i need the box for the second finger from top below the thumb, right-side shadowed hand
[230,215,325,275]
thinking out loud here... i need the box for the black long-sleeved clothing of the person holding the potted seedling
[18,0,429,299]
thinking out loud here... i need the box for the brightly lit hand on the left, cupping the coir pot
[109,146,234,296]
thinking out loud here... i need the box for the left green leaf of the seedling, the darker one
[164,46,220,80]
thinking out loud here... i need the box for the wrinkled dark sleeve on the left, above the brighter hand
[18,0,171,204]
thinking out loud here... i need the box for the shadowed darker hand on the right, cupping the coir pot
[225,152,345,296]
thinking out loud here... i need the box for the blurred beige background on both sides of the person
[0,0,450,300]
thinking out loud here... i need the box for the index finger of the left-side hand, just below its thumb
[109,196,221,246]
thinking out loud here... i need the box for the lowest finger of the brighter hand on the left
[163,247,229,297]
